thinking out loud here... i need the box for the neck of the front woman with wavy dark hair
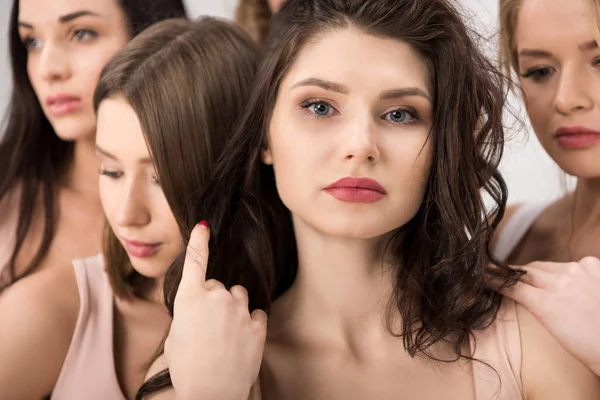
[274,219,393,345]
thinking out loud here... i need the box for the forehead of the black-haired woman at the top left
[19,0,124,23]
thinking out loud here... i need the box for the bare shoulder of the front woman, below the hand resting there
[517,305,600,400]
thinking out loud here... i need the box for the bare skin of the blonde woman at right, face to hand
[500,0,600,375]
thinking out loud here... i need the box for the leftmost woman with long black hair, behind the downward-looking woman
[0,0,186,293]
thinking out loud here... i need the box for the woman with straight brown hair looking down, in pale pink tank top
[0,18,257,400]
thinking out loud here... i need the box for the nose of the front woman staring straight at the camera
[343,115,380,165]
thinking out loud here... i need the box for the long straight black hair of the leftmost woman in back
[0,0,186,291]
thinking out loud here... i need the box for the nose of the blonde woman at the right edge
[554,68,594,115]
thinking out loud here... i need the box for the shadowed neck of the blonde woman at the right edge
[573,178,600,232]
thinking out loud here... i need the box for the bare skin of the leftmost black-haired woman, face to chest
[0,0,130,282]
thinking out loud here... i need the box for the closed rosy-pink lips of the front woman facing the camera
[323,177,387,203]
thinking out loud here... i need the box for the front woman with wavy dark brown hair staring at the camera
[140,0,600,400]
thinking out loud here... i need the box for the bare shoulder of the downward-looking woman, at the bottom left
[0,268,79,399]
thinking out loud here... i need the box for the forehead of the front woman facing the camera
[284,28,431,94]
